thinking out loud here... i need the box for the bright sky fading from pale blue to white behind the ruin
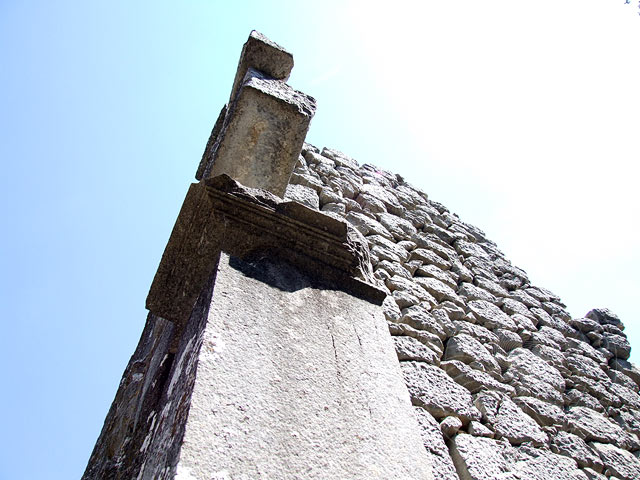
[0,0,640,480]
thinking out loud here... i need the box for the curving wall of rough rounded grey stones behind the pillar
[285,144,640,480]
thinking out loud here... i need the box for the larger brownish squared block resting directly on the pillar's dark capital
[202,68,316,196]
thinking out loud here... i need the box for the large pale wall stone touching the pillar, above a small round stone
[400,362,480,423]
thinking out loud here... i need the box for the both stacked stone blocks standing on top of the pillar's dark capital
[196,31,316,196]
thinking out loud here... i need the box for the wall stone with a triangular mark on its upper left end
[474,392,548,445]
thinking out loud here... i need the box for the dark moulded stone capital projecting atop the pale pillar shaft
[147,175,385,325]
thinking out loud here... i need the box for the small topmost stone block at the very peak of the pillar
[229,30,293,104]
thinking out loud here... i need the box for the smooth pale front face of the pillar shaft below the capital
[177,255,432,480]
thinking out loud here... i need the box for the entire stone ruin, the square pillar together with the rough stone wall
[83,32,640,480]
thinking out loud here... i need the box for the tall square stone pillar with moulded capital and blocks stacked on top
[83,32,432,480]
